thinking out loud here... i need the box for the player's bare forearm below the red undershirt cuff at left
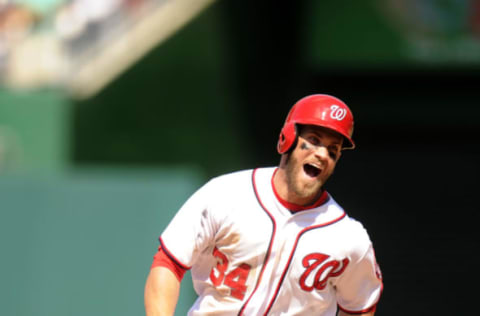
[144,267,180,316]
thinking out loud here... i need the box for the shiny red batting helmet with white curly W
[277,94,355,154]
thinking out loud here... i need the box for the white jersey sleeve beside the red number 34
[160,182,216,269]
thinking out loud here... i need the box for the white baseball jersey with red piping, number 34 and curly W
[160,168,382,316]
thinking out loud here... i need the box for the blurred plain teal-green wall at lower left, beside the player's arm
[0,168,202,316]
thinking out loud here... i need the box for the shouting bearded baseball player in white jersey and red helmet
[145,94,383,316]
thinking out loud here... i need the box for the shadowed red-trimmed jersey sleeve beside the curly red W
[336,244,383,314]
